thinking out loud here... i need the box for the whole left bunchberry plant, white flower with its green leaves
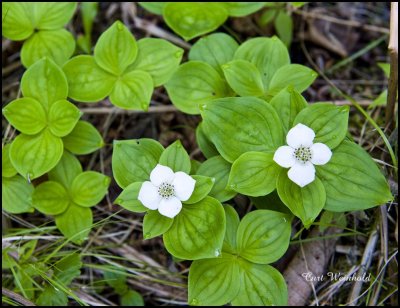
[112,139,225,260]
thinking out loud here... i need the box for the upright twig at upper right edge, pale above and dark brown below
[386,2,399,127]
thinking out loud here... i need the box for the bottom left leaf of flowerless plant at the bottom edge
[188,253,241,306]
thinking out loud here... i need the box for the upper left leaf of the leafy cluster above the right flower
[189,33,239,76]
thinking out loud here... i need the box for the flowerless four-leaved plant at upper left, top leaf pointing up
[63,21,183,110]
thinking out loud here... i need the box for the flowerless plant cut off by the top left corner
[2,2,76,67]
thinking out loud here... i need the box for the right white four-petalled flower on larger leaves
[274,123,332,187]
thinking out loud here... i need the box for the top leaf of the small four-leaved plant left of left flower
[48,151,82,190]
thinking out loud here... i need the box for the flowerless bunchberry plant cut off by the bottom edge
[188,205,292,306]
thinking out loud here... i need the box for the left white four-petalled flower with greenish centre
[138,164,196,218]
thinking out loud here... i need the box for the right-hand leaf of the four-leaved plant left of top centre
[127,38,183,87]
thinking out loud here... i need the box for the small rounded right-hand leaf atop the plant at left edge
[48,99,82,137]
